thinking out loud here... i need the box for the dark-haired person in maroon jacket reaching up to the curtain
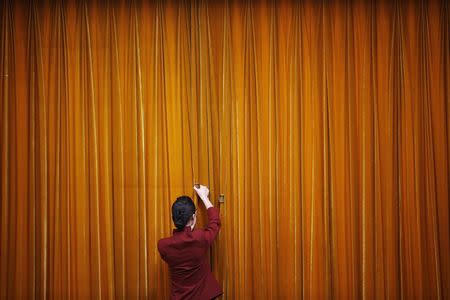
[158,185,223,300]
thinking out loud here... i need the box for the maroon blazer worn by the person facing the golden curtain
[158,207,222,300]
